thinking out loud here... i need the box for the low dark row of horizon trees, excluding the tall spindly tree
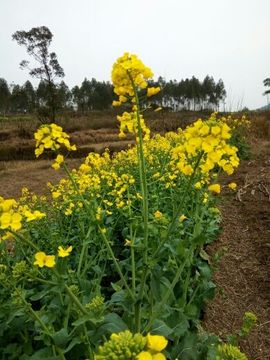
[0,75,226,116]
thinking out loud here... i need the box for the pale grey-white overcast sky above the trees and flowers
[0,0,270,110]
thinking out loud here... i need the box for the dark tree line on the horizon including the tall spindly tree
[0,26,226,118]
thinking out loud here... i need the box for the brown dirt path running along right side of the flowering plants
[204,140,270,360]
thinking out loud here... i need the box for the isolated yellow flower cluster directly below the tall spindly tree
[35,124,76,157]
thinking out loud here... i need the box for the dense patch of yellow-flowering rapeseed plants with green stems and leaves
[0,53,251,360]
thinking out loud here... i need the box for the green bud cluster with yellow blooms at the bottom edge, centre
[95,330,168,360]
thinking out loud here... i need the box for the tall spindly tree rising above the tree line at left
[12,26,65,122]
